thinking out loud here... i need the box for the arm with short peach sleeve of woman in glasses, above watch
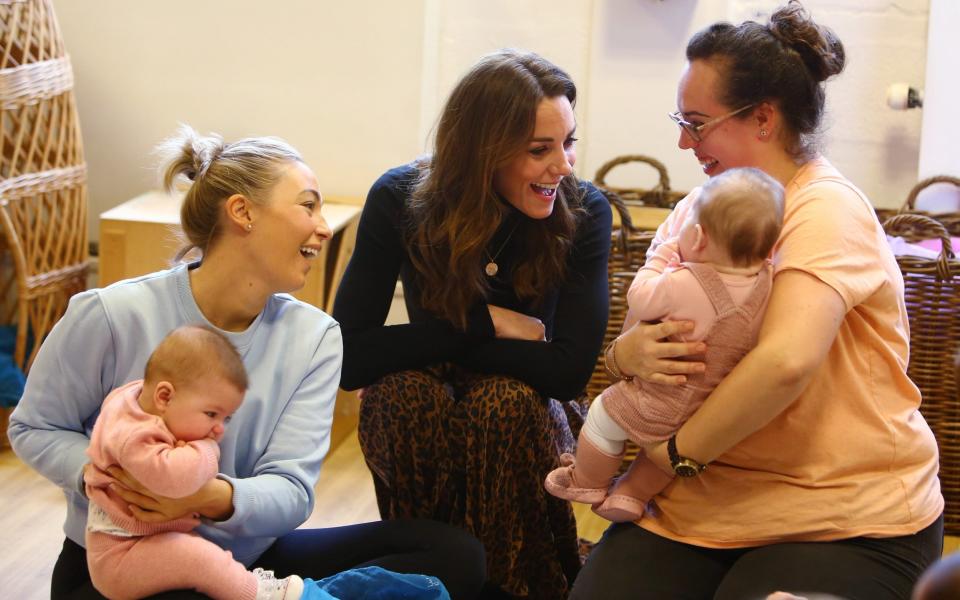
[652,178,876,467]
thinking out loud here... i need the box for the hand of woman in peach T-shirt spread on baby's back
[614,321,707,385]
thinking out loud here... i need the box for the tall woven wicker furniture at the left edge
[0,0,87,370]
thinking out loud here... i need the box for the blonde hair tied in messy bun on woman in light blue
[158,125,303,261]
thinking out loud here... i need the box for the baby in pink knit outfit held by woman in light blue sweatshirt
[84,326,303,600]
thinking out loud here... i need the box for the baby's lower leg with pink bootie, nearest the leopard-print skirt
[544,395,627,504]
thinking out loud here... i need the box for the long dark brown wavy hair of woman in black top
[406,49,582,329]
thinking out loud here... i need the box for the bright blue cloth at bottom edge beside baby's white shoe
[300,567,450,600]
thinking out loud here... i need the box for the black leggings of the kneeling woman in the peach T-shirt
[570,516,943,600]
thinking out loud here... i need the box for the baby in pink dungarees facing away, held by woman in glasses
[545,168,783,521]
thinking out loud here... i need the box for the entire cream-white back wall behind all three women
[54,0,928,238]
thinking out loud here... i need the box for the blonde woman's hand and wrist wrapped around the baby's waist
[107,466,233,523]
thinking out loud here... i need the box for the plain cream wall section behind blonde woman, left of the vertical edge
[54,0,424,239]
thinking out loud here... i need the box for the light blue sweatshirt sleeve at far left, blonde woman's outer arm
[9,290,115,496]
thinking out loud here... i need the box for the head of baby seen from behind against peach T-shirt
[680,168,783,267]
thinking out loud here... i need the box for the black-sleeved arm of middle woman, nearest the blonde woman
[333,167,480,390]
